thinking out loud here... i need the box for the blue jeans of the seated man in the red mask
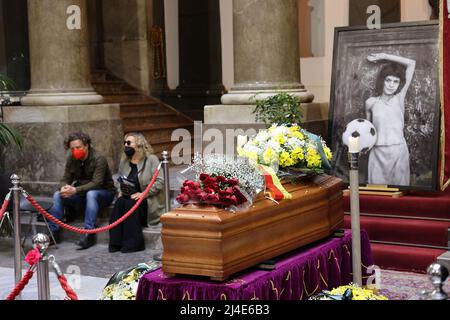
[48,189,114,231]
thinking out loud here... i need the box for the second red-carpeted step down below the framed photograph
[344,214,450,247]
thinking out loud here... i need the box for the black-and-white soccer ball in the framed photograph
[342,119,377,153]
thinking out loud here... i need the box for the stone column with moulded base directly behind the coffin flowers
[222,0,314,105]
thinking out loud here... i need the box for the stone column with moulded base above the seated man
[22,0,103,106]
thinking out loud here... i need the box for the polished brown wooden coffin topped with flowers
[161,175,344,281]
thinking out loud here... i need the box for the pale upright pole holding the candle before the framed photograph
[348,152,362,287]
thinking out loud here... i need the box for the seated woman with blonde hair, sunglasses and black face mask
[109,132,164,253]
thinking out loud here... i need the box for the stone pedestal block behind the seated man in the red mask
[1,105,123,195]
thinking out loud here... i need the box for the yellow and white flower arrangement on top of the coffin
[237,124,332,170]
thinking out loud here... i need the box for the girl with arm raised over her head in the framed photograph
[365,53,416,186]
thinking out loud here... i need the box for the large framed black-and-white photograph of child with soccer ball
[329,21,440,191]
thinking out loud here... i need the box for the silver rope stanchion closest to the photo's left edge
[10,174,22,300]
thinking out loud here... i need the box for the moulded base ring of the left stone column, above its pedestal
[21,91,103,106]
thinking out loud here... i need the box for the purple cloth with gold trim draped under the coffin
[136,230,373,300]
